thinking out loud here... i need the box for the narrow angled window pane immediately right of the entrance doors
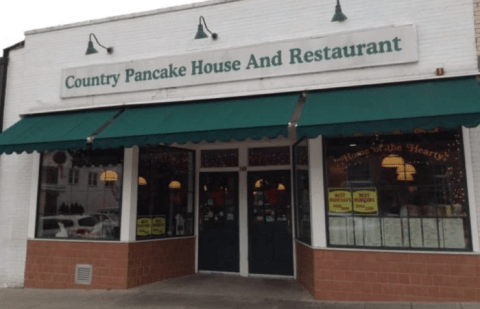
[293,139,311,244]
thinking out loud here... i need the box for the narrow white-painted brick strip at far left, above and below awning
[0,49,32,286]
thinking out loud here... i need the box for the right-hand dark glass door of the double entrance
[248,170,293,276]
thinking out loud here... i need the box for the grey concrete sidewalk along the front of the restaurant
[0,274,480,309]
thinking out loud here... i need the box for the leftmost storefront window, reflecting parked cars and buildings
[36,149,123,240]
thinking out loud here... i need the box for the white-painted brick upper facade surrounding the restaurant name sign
[17,0,477,111]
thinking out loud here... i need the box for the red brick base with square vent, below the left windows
[25,238,195,289]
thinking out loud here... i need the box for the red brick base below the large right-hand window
[297,243,480,302]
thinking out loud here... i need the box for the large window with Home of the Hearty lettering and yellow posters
[325,130,472,250]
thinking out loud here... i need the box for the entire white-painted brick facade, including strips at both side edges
[0,0,480,286]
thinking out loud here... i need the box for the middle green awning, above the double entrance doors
[93,93,299,148]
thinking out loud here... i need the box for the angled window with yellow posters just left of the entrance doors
[137,147,195,240]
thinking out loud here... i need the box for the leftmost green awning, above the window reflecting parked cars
[0,109,119,154]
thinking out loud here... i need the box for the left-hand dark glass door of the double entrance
[198,172,240,272]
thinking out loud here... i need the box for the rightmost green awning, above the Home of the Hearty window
[297,77,480,138]
